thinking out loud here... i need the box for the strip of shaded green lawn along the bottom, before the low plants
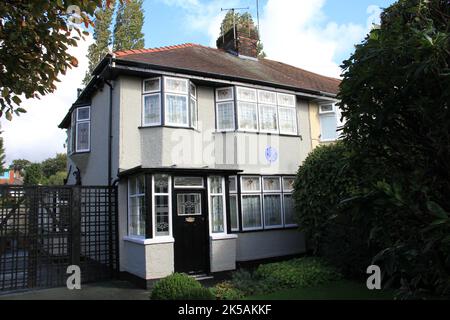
[246,280,394,300]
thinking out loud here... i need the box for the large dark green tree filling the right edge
[339,0,450,297]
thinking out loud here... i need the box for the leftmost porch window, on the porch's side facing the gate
[128,175,145,237]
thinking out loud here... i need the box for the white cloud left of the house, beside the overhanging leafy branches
[0,37,92,165]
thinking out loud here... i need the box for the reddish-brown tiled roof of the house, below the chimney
[115,43,340,94]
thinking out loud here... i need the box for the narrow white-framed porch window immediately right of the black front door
[208,176,227,233]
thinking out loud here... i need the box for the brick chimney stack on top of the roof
[216,21,259,58]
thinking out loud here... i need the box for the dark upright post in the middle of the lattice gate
[71,186,81,267]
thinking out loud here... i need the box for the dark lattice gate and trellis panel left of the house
[0,186,118,292]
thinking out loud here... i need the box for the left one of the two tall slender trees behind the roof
[83,0,116,86]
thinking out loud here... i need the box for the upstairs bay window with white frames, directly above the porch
[142,77,198,128]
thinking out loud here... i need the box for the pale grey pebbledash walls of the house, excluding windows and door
[69,76,317,280]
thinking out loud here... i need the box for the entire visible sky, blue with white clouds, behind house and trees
[0,0,394,164]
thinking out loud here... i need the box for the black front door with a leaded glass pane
[173,190,209,274]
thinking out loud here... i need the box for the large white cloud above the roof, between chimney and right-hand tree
[261,0,368,77]
